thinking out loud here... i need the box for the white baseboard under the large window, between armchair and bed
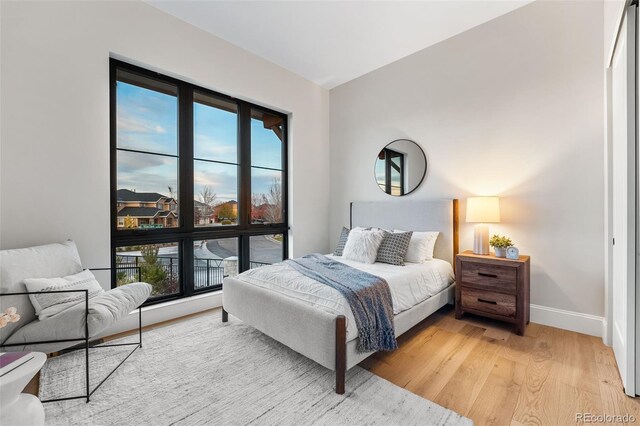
[99,291,222,337]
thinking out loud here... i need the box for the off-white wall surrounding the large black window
[0,2,329,286]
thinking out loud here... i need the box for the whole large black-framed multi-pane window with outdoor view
[111,59,288,303]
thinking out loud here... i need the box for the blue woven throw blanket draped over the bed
[285,254,398,352]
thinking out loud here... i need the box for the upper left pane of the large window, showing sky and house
[115,68,179,230]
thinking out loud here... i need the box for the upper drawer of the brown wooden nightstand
[461,262,518,294]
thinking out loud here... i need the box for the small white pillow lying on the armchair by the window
[24,269,104,320]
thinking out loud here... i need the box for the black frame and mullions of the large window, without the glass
[109,58,289,306]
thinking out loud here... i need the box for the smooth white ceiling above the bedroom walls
[147,0,531,89]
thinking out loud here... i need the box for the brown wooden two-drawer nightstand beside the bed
[456,250,530,336]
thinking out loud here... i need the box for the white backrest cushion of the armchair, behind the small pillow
[0,241,82,344]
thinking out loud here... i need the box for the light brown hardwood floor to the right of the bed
[360,306,640,426]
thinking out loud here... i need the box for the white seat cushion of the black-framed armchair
[5,283,151,352]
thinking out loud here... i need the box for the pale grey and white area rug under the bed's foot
[40,314,473,426]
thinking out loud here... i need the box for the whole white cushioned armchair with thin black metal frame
[0,241,151,402]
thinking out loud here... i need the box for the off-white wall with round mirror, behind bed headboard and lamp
[330,1,604,324]
